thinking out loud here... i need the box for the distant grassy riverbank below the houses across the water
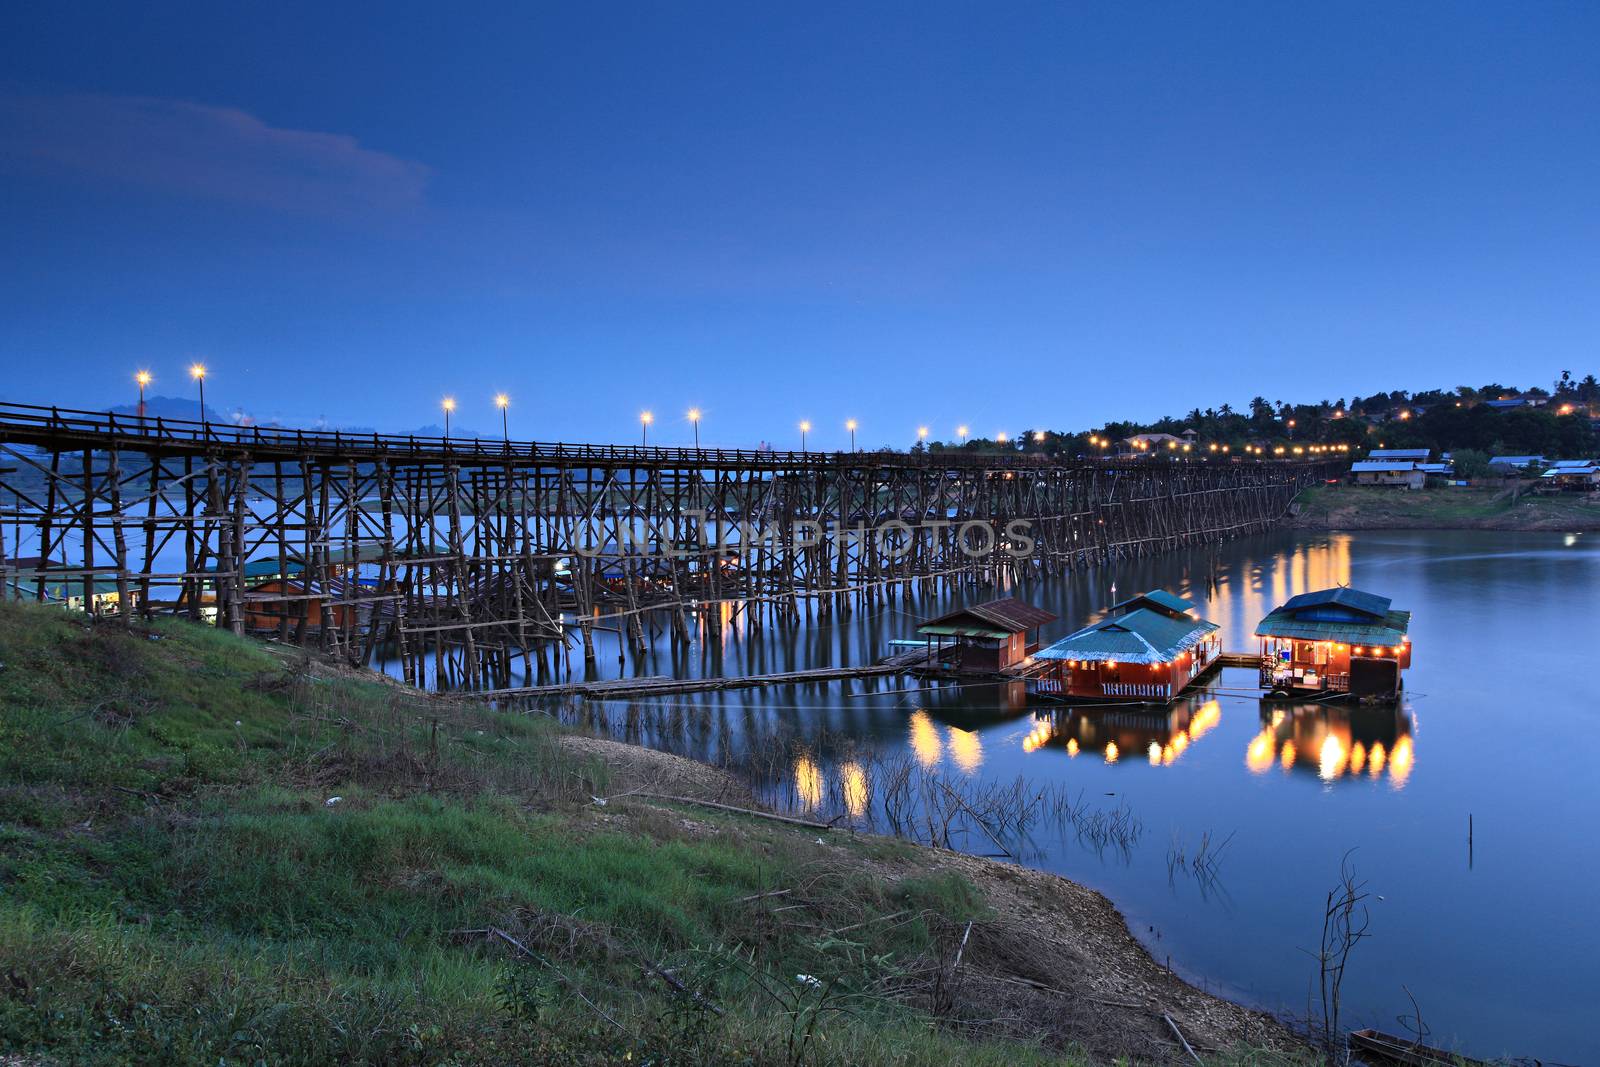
[1288,485,1600,533]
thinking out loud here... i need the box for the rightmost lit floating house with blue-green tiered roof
[1256,585,1411,699]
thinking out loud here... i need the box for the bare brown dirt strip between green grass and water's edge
[585,739,1304,1062]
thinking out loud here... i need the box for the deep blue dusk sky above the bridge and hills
[0,3,1600,446]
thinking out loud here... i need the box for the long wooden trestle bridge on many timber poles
[0,403,1328,691]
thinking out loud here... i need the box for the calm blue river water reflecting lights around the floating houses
[540,531,1600,1064]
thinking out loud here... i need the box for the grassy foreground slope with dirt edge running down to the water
[0,603,1296,1067]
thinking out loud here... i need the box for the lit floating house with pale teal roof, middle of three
[1034,589,1221,704]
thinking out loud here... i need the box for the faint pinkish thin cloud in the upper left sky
[0,94,432,216]
